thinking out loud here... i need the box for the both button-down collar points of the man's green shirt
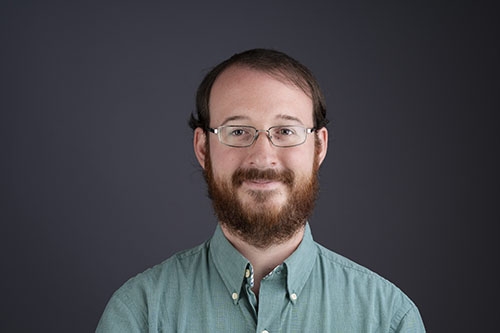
[210,223,317,302]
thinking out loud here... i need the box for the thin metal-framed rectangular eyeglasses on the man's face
[208,125,315,148]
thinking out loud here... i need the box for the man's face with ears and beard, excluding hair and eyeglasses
[195,66,327,247]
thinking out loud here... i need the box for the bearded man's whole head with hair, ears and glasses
[190,50,328,248]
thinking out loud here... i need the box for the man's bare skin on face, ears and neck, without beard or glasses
[194,66,328,293]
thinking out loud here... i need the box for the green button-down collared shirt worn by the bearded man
[97,225,425,333]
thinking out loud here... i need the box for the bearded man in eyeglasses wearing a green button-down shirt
[97,49,425,333]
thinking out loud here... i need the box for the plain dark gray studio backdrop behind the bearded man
[0,1,500,332]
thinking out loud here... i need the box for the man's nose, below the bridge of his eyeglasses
[248,130,277,169]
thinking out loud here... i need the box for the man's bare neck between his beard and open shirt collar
[220,224,304,295]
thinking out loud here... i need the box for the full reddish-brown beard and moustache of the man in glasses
[204,147,319,248]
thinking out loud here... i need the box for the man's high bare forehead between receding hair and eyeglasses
[209,66,313,126]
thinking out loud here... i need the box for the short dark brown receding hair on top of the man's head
[189,49,328,131]
